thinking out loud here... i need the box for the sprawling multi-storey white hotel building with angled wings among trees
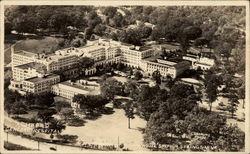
[10,39,213,93]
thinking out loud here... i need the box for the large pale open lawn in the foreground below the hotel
[63,109,147,151]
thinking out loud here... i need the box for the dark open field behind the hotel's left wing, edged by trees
[15,37,61,53]
